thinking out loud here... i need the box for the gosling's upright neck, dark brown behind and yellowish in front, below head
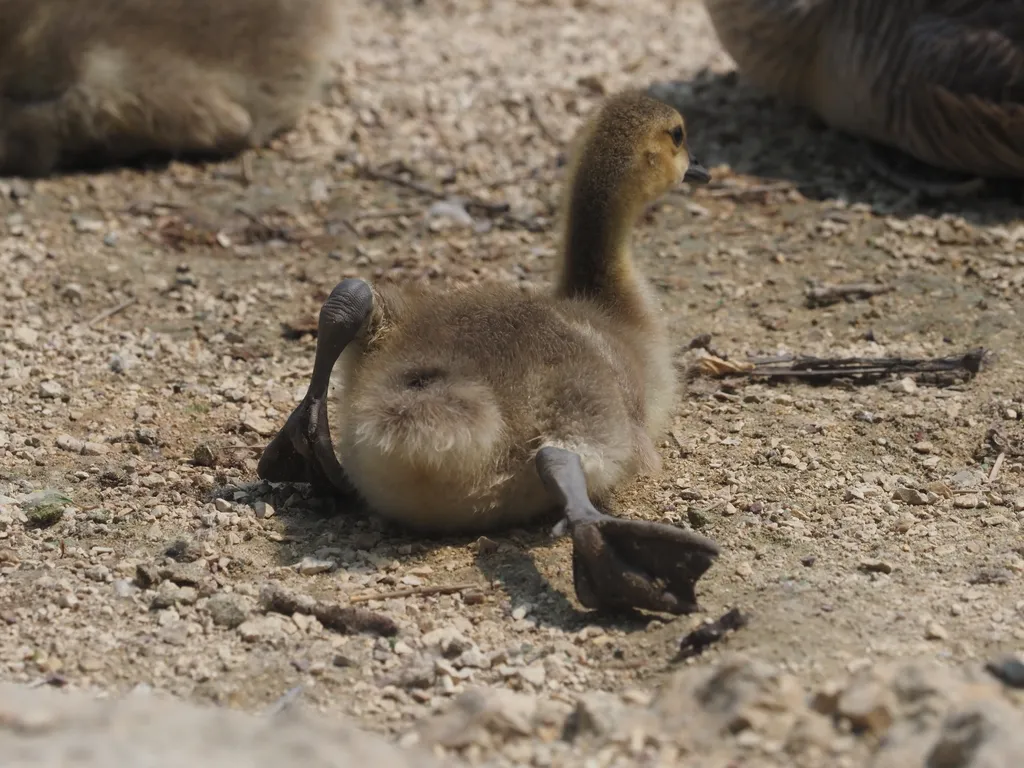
[556,167,647,317]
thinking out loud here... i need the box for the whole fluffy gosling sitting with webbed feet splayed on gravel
[257,91,718,613]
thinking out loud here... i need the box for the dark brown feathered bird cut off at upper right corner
[705,0,1024,177]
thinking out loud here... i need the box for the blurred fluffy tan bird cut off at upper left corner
[0,0,338,175]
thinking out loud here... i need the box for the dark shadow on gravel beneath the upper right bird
[650,70,1024,225]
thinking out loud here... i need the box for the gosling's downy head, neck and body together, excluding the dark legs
[331,92,707,531]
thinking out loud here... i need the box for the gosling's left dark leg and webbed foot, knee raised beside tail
[256,279,374,494]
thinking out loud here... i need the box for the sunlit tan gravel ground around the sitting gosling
[0,0,1024,766]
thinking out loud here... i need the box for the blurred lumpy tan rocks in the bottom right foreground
[403,657,1024,768]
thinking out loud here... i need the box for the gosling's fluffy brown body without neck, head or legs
[332,286,673,530]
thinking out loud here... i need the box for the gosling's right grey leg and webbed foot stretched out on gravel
[537,446,719,613]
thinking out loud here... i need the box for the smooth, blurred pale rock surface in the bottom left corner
[0,684,437,768]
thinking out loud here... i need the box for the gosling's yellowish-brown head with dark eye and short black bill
[573,91,711,218]
